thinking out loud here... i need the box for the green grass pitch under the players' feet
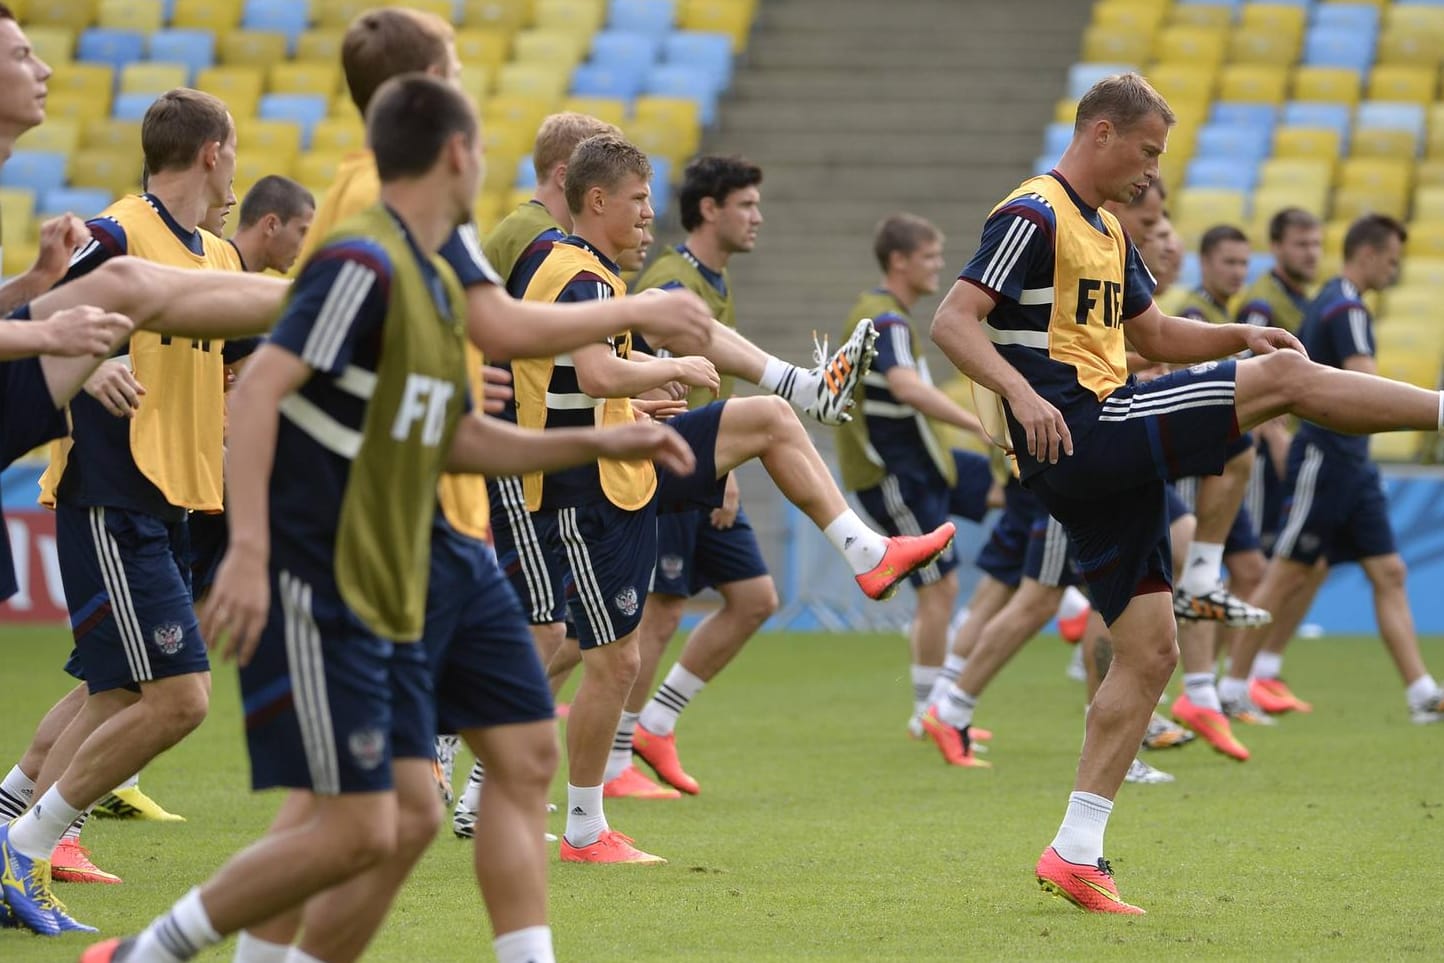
[0,629,1444,963]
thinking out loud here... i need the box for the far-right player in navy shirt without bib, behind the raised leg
[1220,214,1444,723]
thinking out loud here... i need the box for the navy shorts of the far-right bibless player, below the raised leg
[1274,439,1398,565]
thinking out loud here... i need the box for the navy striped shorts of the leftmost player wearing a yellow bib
[55,502,211,693]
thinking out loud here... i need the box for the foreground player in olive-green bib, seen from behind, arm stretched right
[76,75,693,962]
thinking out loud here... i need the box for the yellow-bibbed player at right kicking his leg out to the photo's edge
[933,74,1444,914]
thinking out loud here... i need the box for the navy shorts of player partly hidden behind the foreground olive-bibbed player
[421,513,556,730]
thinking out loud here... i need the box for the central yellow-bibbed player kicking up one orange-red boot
[513,134,953,863]
